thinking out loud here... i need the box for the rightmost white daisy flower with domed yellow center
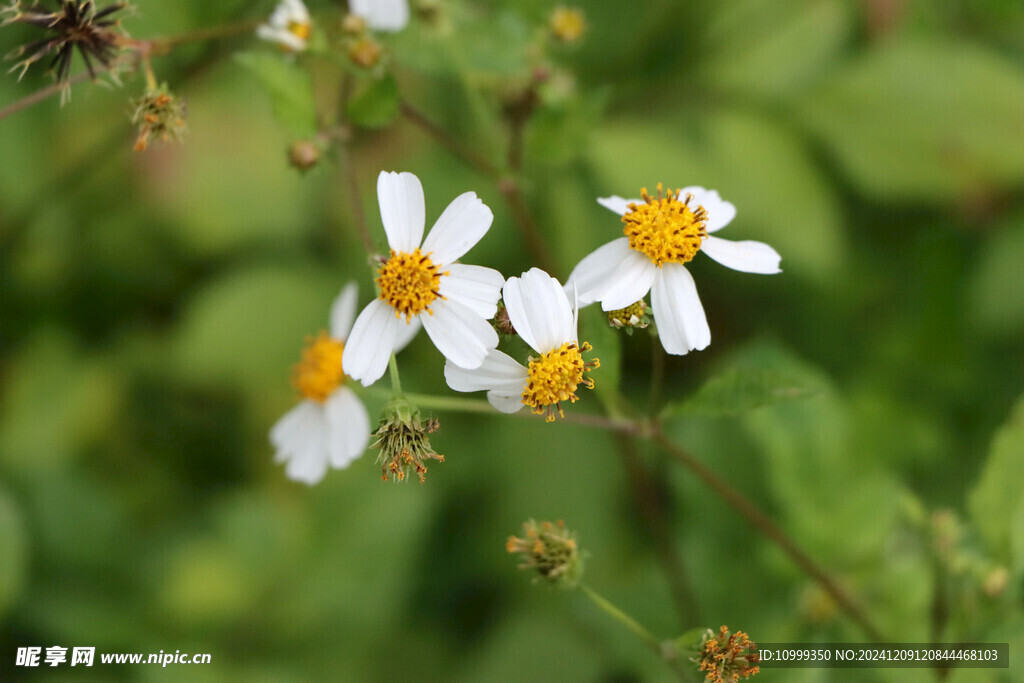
[568,183,781,355]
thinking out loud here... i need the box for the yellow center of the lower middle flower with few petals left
[522,342,601,422]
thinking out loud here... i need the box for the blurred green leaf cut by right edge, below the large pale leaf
[968,214,1024,336]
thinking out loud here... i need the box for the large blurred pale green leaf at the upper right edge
[798,37,1024,204]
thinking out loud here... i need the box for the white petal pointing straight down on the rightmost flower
[650,263,711,355]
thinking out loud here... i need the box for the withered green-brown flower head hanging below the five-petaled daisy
[372,397,444,483]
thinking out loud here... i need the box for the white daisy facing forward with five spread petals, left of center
[343,171,505,386]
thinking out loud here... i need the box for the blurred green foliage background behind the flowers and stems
[0,0,1024,683]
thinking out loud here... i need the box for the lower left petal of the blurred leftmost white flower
[270,400,328,485]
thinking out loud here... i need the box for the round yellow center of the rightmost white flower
[623,183,708,268]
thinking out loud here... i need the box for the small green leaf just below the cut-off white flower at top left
[234,52,316,137]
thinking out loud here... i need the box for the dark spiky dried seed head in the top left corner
[0,0,128,91]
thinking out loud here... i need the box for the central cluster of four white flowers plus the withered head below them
[271,165,779,483]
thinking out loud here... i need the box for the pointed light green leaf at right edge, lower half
[968,396,1024,560]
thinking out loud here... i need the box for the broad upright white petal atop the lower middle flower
[504,268,575,353]
